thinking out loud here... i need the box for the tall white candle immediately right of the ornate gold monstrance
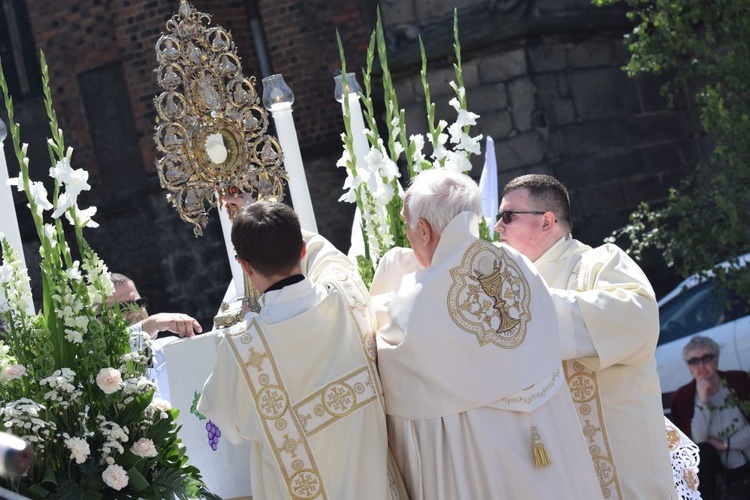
[270,102,318,233]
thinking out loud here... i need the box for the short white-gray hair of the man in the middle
[404,169,482,234]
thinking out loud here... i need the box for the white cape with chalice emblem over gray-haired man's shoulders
[378,212,560,420]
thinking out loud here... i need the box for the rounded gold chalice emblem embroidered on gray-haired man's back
[448,240,531,349]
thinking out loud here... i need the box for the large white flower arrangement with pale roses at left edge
[0,54,215,499]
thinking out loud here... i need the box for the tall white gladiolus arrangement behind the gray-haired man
[336,10,487,284]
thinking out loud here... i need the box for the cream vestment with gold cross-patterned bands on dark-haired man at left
[198,238,405,500]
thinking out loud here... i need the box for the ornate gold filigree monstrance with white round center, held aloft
[154,0,286,236]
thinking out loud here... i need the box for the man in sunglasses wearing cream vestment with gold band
[495,174,677,500]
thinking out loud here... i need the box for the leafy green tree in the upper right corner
[594,0,750,299]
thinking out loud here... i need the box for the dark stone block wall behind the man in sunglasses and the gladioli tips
[381,0,703,292]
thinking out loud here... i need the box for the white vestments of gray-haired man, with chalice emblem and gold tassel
[373,212,601,500]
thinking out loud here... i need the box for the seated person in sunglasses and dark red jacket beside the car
[670,335,750,500]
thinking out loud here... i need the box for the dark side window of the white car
[659,281,729,345]
